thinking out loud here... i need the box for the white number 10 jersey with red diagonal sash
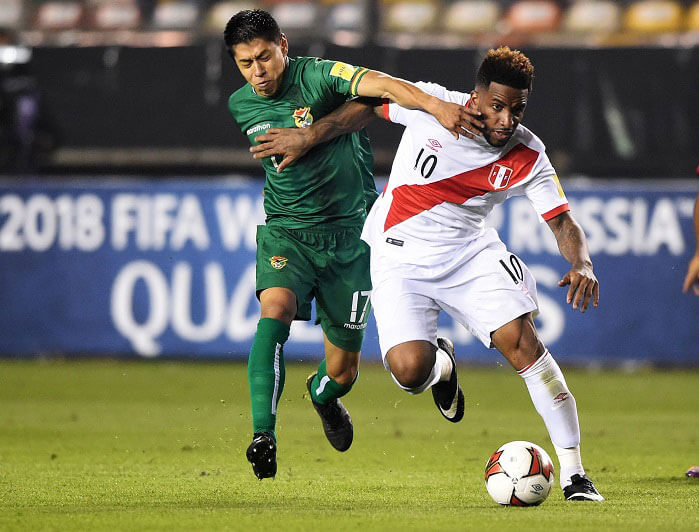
[362,82,569,258]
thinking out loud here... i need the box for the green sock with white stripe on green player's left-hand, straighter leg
[248,318,289,440]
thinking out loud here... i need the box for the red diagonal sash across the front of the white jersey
[384,144,539,231]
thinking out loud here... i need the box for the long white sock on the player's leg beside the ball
[518,350,583,485]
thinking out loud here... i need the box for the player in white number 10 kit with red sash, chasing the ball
[253,47,604,501]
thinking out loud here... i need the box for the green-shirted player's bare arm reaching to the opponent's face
[357,70,484,139]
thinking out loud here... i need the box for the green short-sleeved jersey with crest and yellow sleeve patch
[228,57,376,229]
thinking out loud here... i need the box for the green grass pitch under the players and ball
[0,361,699,532]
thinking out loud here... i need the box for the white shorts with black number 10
[371,232,538,360]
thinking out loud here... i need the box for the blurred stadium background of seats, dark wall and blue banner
[0,0,699,366]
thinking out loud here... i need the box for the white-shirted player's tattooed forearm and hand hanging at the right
[548,212,599,312]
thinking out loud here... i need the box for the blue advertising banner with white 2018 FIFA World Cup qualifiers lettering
[0,177,699,365]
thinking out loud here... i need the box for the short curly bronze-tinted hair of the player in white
[476,46,534,92]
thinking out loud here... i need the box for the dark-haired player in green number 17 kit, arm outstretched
[224,10,478,479]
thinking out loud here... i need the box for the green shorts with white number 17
[255,225,371,352]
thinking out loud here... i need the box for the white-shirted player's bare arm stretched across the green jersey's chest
[250,98,380,173]
